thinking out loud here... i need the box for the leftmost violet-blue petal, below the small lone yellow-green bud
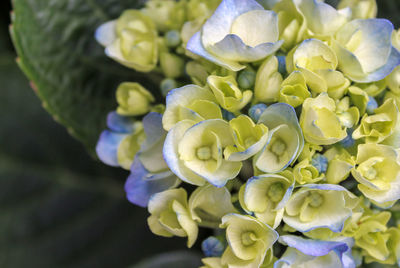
[96,130,128,167]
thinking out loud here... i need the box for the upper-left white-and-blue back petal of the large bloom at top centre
[201,0,264,48]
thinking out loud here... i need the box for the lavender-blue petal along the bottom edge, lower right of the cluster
[279,235,349,258]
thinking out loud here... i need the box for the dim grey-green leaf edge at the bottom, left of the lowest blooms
[131,251,201,268]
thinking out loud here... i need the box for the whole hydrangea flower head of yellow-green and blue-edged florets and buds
[96,0,400,268]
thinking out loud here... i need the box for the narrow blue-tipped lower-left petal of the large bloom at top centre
[186,32,246,72]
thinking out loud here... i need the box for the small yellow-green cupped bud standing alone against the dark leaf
[117,82,154,116]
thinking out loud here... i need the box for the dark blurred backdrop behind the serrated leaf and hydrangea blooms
[0,0,400,268]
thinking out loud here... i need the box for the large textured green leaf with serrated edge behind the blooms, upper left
[11,0,160,154]
